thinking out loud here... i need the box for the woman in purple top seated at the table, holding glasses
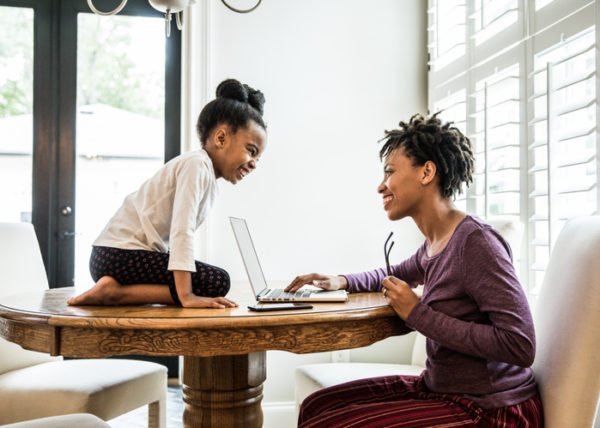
[286,115,543,428]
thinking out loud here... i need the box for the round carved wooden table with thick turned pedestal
[0,282,407,427]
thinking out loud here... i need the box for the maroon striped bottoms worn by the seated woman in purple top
[298,376,544,428]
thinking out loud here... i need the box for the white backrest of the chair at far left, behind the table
[0,223,56,374]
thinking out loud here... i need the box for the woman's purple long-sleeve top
[345,216,537,409]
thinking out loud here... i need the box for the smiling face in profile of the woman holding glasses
[377,148,424,220]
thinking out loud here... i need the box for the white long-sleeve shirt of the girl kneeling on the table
[93,149,218,272]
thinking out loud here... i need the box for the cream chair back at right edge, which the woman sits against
[533,216,600,428]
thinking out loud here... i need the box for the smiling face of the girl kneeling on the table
[209,120,267,184]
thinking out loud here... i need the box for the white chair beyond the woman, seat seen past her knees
[295,217,523,410]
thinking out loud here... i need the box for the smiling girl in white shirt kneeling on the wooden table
[67,79,267,308]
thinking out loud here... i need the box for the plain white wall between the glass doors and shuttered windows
[186,0,427,424]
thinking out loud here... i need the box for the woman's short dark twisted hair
[379,113,475,198]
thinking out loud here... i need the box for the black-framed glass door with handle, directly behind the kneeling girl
[55,0,181,288]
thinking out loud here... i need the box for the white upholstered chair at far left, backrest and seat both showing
[0,223,167,428]
